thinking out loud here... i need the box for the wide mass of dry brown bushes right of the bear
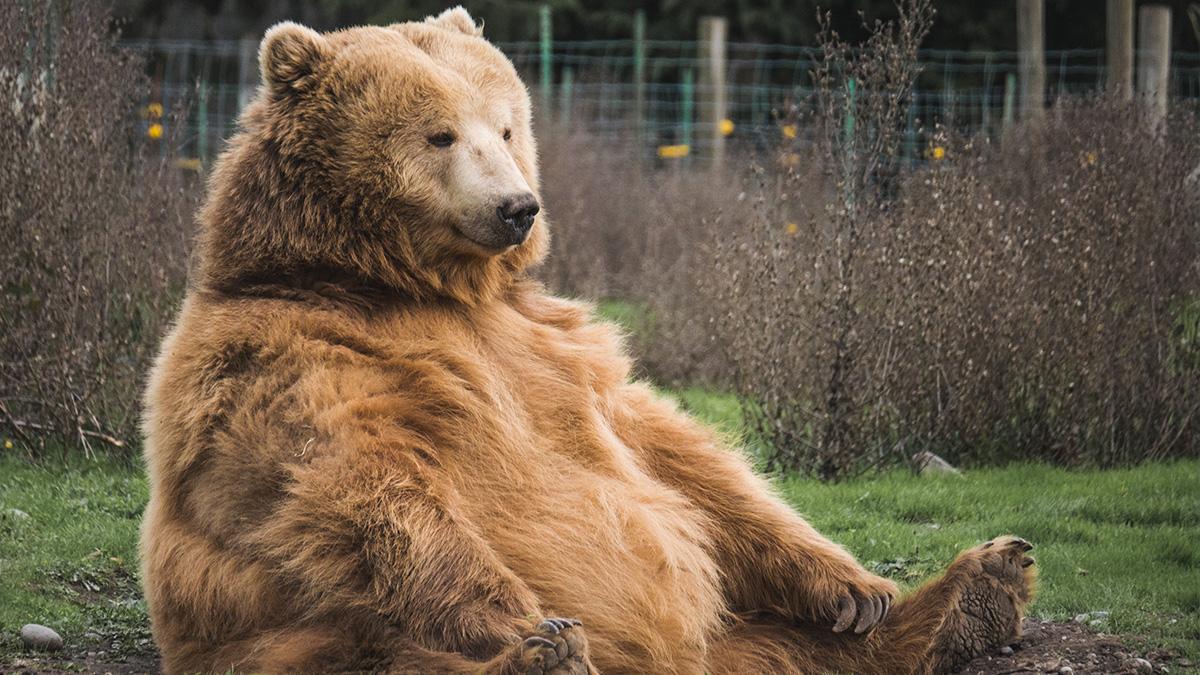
[547,2,1200,478]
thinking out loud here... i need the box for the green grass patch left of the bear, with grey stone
[0,456,150,655]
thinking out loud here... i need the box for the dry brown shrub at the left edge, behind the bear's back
[0,2,194,454]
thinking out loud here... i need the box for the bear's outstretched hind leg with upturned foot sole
[709,537,1034,675]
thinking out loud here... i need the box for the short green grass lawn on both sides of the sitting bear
[0,417,1200,673]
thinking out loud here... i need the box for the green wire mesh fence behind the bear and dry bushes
[126,40,1200,167]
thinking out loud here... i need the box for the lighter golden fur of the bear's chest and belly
[408,309,724,655]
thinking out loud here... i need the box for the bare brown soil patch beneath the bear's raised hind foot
[962,619,1192,675]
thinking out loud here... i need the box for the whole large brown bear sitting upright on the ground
[142,8,1033,674]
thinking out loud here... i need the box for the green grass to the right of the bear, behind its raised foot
[671,388,1200,661]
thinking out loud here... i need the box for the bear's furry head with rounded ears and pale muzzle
[199,7,547,304]
